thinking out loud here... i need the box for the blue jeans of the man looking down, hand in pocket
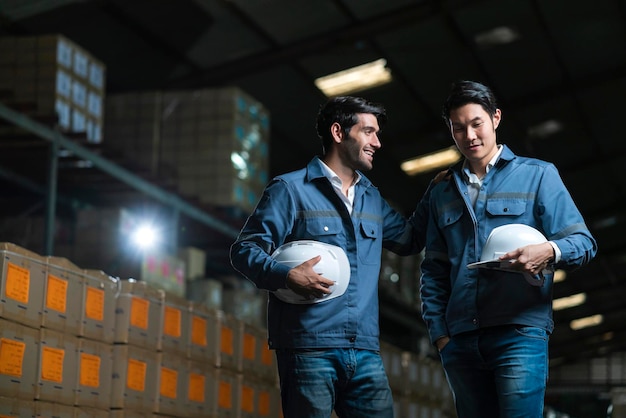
[440,325,548,418]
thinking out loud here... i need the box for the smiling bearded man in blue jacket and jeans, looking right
[230,97,428,418]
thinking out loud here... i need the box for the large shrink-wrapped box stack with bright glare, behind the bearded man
[105,87,269,212]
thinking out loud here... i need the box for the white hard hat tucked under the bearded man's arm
[272,240,350,304]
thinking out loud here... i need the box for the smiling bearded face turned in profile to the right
[337,113,382,171]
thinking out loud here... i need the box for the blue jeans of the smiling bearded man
[276,348,393,418]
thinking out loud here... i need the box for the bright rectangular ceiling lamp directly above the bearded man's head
[315,58,391,97]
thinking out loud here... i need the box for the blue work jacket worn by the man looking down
[420,146,597,343]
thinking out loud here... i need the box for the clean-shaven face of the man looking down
[449,103,501,175]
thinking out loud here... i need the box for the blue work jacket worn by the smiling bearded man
[230,157,426,350]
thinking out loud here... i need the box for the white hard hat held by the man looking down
[467,224,548,286]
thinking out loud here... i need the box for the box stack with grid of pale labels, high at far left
[0,34,106,143]
